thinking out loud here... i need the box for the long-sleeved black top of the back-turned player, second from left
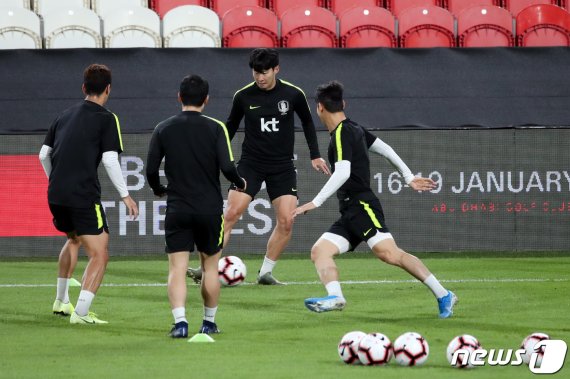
[146,111,244,214]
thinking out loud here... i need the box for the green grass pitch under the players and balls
[0,253,570,379]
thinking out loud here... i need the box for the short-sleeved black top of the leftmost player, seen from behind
[44,100,123,208]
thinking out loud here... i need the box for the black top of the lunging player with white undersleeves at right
[328,119,376,208]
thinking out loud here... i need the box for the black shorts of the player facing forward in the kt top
[230,160,298,201]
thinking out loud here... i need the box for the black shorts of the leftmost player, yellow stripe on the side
[49,203,109,236]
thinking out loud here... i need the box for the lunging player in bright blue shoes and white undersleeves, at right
[292,81,457,318]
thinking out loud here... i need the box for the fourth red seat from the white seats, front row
[398,6,456,47]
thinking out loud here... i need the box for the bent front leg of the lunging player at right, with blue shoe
[305,229,350,312]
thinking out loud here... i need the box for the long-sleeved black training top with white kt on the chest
[226,79,320,166]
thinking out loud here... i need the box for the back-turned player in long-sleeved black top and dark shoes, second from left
[146,75,246,338]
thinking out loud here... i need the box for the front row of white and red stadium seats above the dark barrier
[0,0,570,49]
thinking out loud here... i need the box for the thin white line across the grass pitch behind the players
[0,278,570,288]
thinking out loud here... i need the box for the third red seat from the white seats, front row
[340,6,398,47]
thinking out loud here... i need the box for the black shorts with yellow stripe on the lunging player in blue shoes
[328,199,390,250]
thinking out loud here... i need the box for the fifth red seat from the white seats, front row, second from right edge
[457,5,515,47]
